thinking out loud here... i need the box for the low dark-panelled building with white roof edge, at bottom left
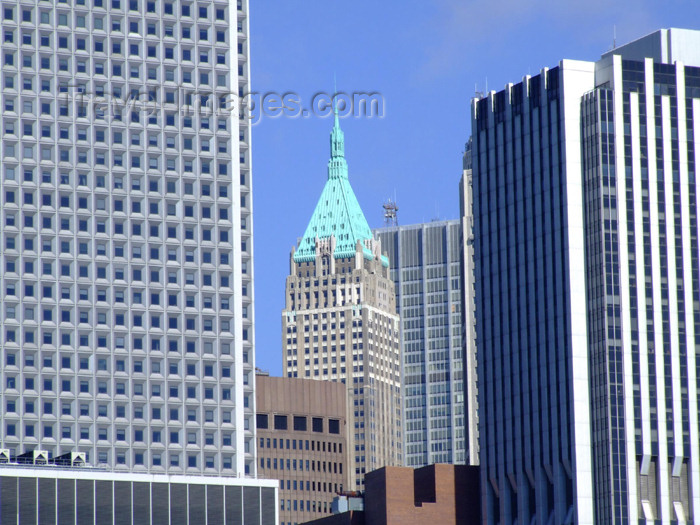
[0,458,278,525]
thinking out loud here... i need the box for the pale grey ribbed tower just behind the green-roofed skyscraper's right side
[374,220,476,467]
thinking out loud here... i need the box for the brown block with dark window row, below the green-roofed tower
[255,374,351,525]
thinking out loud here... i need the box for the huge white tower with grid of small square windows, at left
[0,0,255,476]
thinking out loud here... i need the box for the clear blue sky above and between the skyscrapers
[250,0,700,375]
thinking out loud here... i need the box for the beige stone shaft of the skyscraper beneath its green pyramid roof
[282,266,403,489]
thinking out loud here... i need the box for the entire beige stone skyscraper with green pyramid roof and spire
[282,110,403,488]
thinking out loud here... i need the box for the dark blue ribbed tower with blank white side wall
[472,61,593,524]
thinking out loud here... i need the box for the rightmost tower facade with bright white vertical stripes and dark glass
[582,56,700,523]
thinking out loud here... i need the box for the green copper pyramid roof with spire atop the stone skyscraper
[294,109,373,263]
